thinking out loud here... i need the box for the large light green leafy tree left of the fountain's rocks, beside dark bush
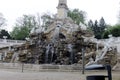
[11,15,40,40]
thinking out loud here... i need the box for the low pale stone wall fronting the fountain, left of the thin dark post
[0,63,82,71]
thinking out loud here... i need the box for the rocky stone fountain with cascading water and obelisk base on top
[6,0,117,66]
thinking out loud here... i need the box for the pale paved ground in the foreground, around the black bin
[0,69,120,80]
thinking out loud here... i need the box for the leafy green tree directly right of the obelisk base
[68,9,86,25]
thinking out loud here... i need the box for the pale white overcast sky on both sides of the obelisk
[0,0,120,31]
